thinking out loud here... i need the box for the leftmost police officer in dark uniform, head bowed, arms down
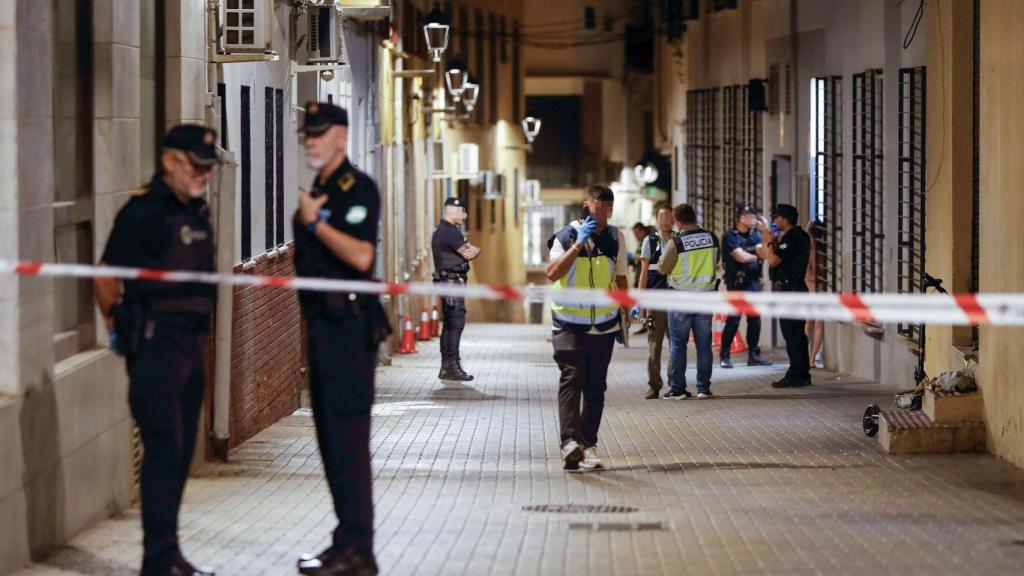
[95,125,219,576]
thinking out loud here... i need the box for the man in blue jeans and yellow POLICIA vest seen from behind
[657,204,721,400]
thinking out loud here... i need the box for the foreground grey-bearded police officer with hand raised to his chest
[293,102,390,575]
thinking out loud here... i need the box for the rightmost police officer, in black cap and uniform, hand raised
[759,204,811,388]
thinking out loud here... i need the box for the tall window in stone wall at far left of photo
[53,1,96,362]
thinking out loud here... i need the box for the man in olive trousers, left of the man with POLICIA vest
[631,204,673,400]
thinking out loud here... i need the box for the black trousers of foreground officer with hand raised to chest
[306,314,377,551]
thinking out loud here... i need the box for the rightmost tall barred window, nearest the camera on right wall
[896,67,927,338]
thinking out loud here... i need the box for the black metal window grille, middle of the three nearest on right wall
[850,70,885,292]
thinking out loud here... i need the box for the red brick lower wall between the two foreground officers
[230,244,306,447]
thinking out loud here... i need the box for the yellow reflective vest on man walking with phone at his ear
[548,224,618,332]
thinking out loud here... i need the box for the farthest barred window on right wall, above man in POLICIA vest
[686,88,723,228]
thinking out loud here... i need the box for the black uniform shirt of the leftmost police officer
[101,174,217,301]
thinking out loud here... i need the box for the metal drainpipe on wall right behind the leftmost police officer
[206,0,231,462]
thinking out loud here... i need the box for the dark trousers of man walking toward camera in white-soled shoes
[551,331,615,448]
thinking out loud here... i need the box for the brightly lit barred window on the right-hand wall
[808,76,843,292]
